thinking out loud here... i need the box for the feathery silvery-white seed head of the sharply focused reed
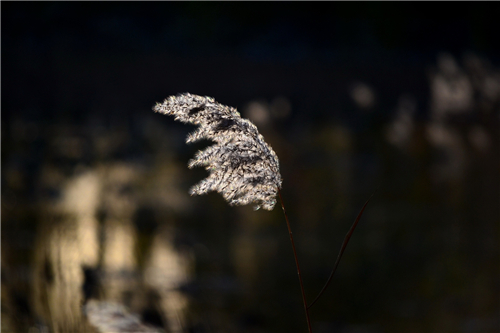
[153,93,282,210]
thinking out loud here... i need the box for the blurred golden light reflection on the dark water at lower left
[2,164,193,332]
